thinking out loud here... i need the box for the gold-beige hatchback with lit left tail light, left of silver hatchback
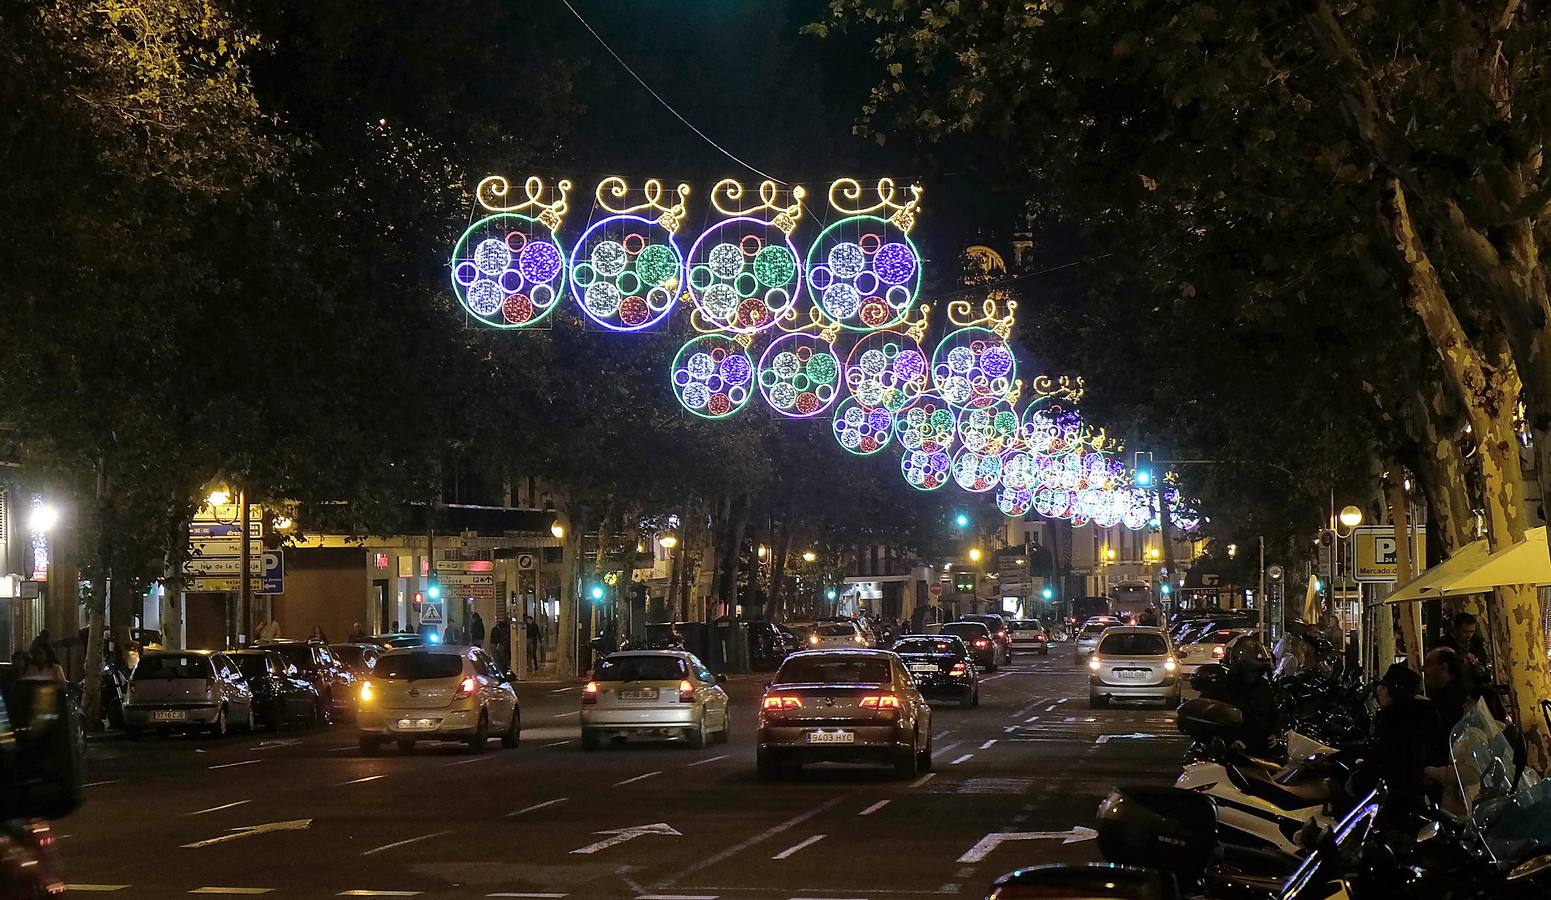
[357,646,523,756]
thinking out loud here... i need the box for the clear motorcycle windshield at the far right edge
[1449,703,1551,863]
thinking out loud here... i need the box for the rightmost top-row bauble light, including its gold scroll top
[807,178,921,331]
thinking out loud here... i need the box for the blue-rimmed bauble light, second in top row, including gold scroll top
[571,177,689,332]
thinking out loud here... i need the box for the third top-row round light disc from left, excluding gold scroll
[687,216,802,334]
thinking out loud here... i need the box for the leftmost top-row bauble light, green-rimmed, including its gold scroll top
[451,175,571,329]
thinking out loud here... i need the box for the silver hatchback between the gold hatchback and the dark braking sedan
[582,650,729,749]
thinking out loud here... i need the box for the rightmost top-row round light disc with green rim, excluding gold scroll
[805,216,921,332]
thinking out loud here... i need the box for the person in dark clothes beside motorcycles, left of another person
[1356,663,1447,810]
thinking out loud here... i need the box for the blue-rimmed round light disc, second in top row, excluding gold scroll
[571,216,684,331]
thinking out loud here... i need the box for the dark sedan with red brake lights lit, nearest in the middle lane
[755,649,932,779]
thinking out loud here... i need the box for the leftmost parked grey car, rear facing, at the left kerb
[124,650,253,740]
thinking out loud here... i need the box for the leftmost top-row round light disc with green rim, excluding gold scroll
[451,213,566,329]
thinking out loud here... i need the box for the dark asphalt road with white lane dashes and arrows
[56,646,1185,900]
